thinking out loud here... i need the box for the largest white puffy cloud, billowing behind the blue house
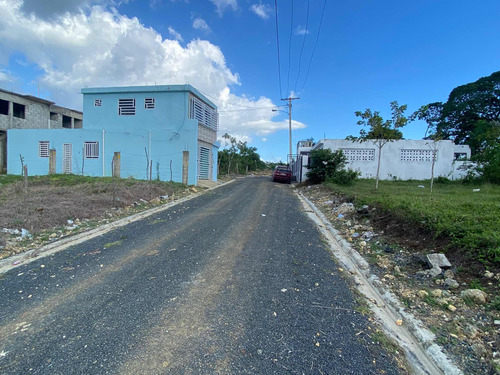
[0,0,305,140]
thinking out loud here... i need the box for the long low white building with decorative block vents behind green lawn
[301,139,471,180]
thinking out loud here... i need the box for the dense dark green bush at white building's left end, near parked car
[307,149,347,184]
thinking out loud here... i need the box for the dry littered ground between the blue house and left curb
[0,176,195,259]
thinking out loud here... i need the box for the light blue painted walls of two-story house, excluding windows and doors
[7,85,218,184]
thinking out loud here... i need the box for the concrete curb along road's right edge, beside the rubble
[297,191,463,375]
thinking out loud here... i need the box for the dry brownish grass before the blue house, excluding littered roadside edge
[0,175,186,234]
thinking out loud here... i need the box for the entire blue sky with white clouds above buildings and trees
[0,0,500,162]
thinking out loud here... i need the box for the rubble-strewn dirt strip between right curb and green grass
[299,185,500,374]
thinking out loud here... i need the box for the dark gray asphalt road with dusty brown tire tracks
[0,178,399,375]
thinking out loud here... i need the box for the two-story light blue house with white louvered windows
[7,85,219,184]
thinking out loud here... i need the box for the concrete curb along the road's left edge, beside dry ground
[0,180,236,274]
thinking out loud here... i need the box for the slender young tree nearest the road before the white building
[347,101,409,189]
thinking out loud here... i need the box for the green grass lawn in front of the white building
[326,180,500,265]
